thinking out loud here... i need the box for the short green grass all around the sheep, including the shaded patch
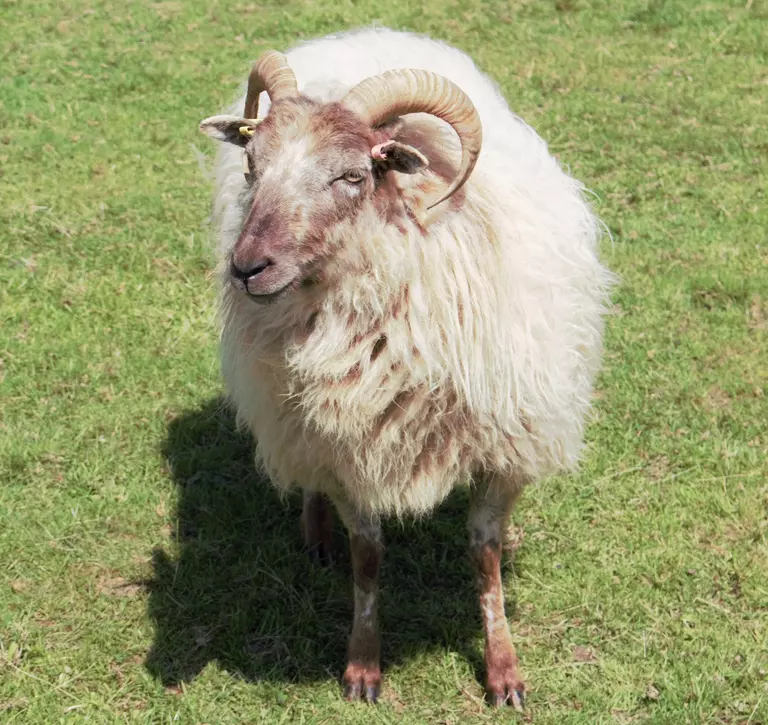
[0,0,768,725]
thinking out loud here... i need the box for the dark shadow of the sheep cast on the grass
[145,398,514,686]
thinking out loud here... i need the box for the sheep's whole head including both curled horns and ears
[200,51,481,301]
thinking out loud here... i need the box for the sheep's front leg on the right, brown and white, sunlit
[469,478,525,710]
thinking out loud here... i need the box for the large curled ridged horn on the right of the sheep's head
[342,69,483,209]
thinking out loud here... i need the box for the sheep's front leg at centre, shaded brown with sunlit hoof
[334,500,384,703]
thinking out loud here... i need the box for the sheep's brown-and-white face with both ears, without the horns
[201,98,427,301]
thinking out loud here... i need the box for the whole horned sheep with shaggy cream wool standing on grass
[200,28,612,709]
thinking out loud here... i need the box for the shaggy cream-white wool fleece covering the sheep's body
[202,28,612,515]
